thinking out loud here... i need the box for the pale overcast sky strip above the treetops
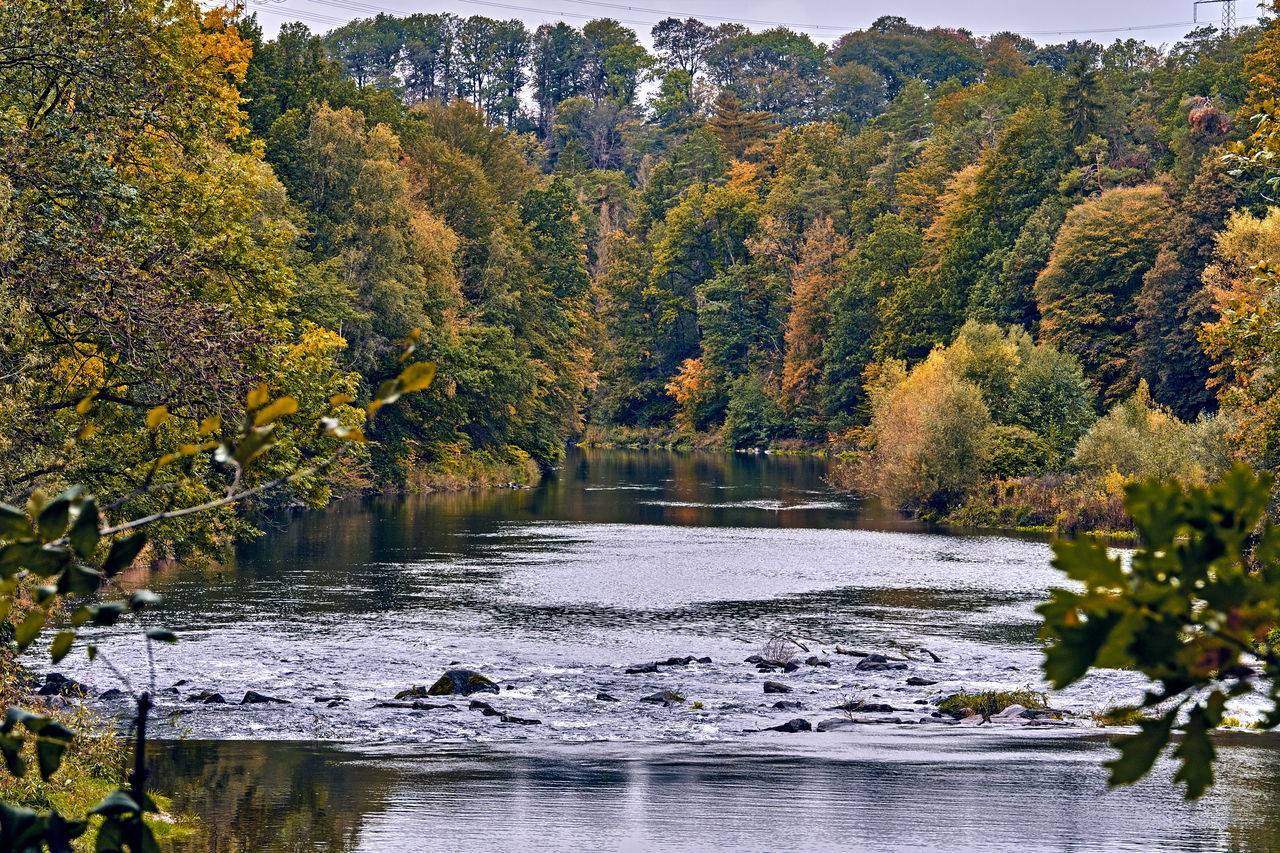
[244,0,1258,45]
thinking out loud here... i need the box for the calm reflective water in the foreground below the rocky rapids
[157,730,1280,853]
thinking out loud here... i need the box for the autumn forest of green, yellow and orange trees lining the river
[0,0,1280,555]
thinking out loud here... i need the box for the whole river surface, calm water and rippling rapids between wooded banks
[64,451,1280,853]
